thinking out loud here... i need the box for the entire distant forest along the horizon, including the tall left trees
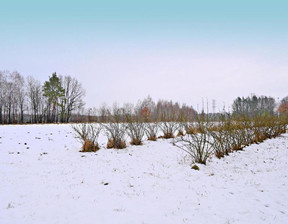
[0,71,288,124]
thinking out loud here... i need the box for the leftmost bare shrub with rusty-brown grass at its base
[72,123,101,152]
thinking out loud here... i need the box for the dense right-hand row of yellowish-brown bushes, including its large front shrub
[174,114,287,164]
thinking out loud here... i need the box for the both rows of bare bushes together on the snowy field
[72,114,288,164]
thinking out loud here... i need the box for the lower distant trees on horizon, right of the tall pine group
[86,95,288,122]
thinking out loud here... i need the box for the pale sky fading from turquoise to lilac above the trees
[0,0,288,110]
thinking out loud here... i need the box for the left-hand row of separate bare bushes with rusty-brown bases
[72,121,180,152]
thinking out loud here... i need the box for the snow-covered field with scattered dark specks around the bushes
[0,125,288,224]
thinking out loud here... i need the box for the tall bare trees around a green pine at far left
[0,71,85,124]
